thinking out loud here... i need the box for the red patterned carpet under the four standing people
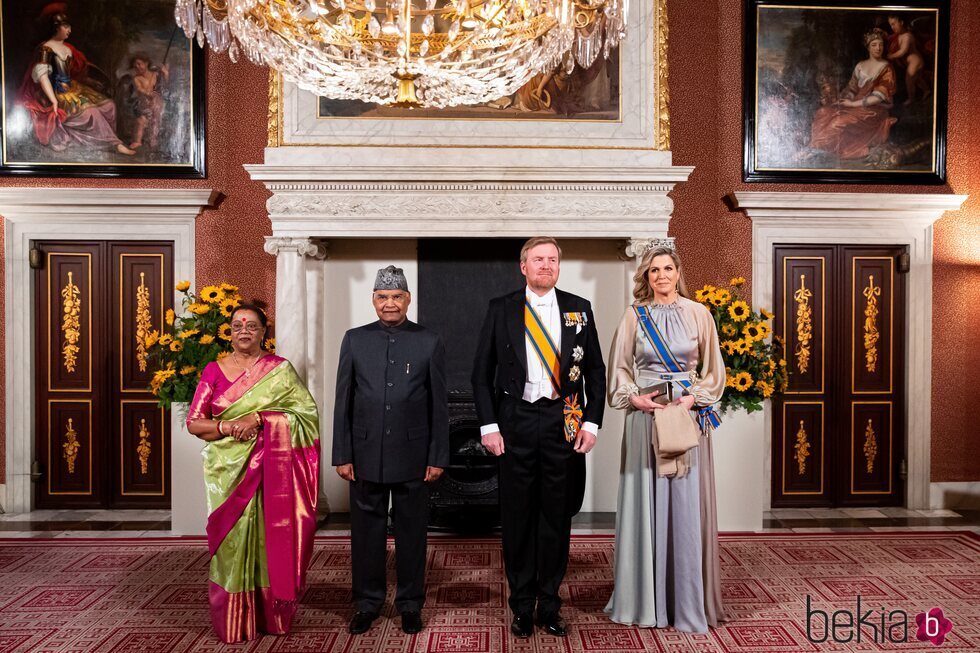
[0,531,980,653]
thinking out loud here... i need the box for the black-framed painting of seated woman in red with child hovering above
[743,0,949,184]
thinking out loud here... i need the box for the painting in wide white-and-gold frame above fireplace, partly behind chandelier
[269,0,670,150]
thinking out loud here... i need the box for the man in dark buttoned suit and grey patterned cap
[333,266,449,635]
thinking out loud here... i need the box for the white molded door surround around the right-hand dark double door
[731,192,967,509]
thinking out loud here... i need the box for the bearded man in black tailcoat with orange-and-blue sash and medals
[472,237,606,637]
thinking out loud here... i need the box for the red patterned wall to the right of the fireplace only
[668,0,980,482]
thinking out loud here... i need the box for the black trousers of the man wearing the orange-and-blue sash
[498,396,574,615]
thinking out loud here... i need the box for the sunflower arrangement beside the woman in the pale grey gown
[694,277,788,413]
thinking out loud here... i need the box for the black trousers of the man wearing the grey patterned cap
[350,479,429,613]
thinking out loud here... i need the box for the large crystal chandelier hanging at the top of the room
[175,0,629,107]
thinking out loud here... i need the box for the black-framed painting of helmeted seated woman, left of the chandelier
[0,0,205,178]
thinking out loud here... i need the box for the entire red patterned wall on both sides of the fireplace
[0,0,980,482]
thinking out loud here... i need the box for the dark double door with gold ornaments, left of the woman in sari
[34,241,173,508]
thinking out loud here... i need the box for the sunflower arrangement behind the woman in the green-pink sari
[144,281,271,408]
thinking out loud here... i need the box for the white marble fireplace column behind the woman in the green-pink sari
[265,236,327,380]
